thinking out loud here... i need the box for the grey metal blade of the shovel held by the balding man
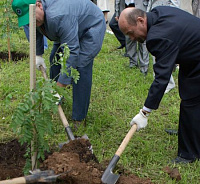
[101,155,120,184]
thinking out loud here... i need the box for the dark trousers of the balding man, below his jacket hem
[178,96,200,160]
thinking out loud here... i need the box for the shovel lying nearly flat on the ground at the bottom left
[0,169,61,184]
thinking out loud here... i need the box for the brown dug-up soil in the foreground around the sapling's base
[0,138,151,184]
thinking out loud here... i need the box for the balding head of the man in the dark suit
[118,7,147,42]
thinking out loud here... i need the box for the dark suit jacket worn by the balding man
[144,6,200,109]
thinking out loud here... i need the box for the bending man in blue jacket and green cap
[12,0,106,124]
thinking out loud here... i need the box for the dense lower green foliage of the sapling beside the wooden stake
[11,78,58,169]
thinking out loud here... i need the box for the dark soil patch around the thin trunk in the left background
[0,51,29,61]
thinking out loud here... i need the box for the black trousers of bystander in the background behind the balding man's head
[109,13,125,45]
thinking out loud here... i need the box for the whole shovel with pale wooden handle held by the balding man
[101,124,137,184]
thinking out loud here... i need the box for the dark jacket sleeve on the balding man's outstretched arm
[144,38,179,109]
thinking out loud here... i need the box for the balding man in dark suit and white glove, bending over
[119,6,200,163]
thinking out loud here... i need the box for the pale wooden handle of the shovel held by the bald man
[115,124,137,157]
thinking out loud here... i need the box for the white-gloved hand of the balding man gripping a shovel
[130,109,148,131]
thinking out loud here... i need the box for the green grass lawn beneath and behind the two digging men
[0,30,200,184]
